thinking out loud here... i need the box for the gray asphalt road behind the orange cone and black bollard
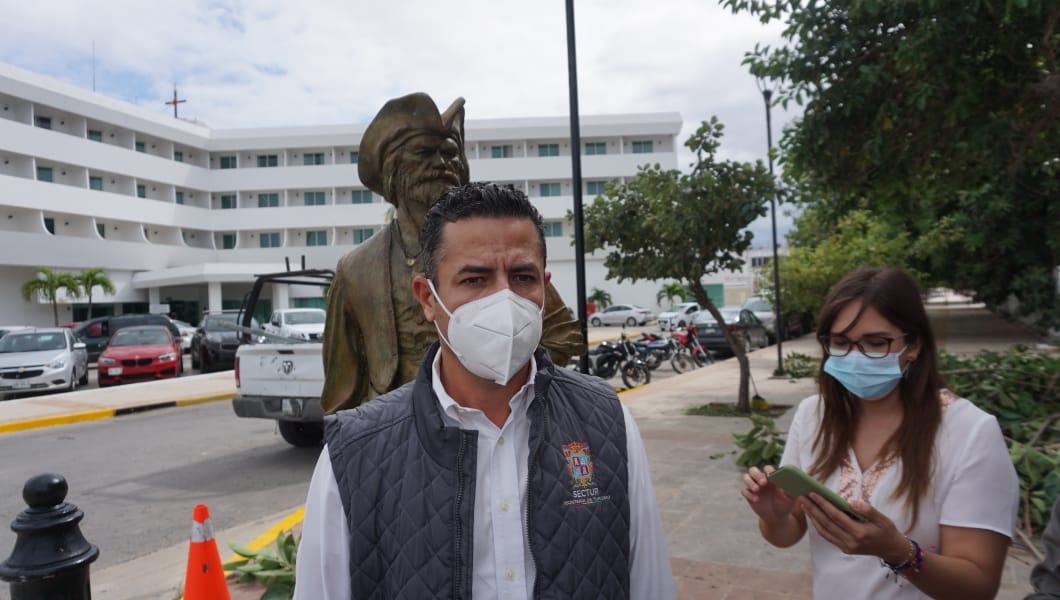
[0,402,319,585]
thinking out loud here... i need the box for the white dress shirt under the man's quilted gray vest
[295,355,676,600]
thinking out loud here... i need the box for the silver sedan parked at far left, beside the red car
[0,328,88,398]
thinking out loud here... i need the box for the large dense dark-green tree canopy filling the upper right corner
[721,0,1060,324]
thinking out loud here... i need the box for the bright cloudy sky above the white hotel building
[0,0,794,246]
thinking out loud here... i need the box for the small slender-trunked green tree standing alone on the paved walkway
[584,118,774,412]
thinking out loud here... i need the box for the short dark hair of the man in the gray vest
[420,181,547,281]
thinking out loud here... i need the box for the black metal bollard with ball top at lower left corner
[0,473,100,600]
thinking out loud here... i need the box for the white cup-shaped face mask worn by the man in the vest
[427,280,543,386]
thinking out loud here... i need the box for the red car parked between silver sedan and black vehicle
[96,325,183,388]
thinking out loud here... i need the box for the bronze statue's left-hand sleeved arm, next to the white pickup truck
[320,270,368,414]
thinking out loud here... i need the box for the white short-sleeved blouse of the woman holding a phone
[780,390,1020,600]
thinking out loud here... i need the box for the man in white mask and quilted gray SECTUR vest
[295,183,675,600]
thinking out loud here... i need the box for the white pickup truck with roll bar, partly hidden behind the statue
[232,269,335,446]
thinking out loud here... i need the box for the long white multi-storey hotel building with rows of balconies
[0,64,682,325]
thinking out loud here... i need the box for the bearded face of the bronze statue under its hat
[386,134,463,210]
